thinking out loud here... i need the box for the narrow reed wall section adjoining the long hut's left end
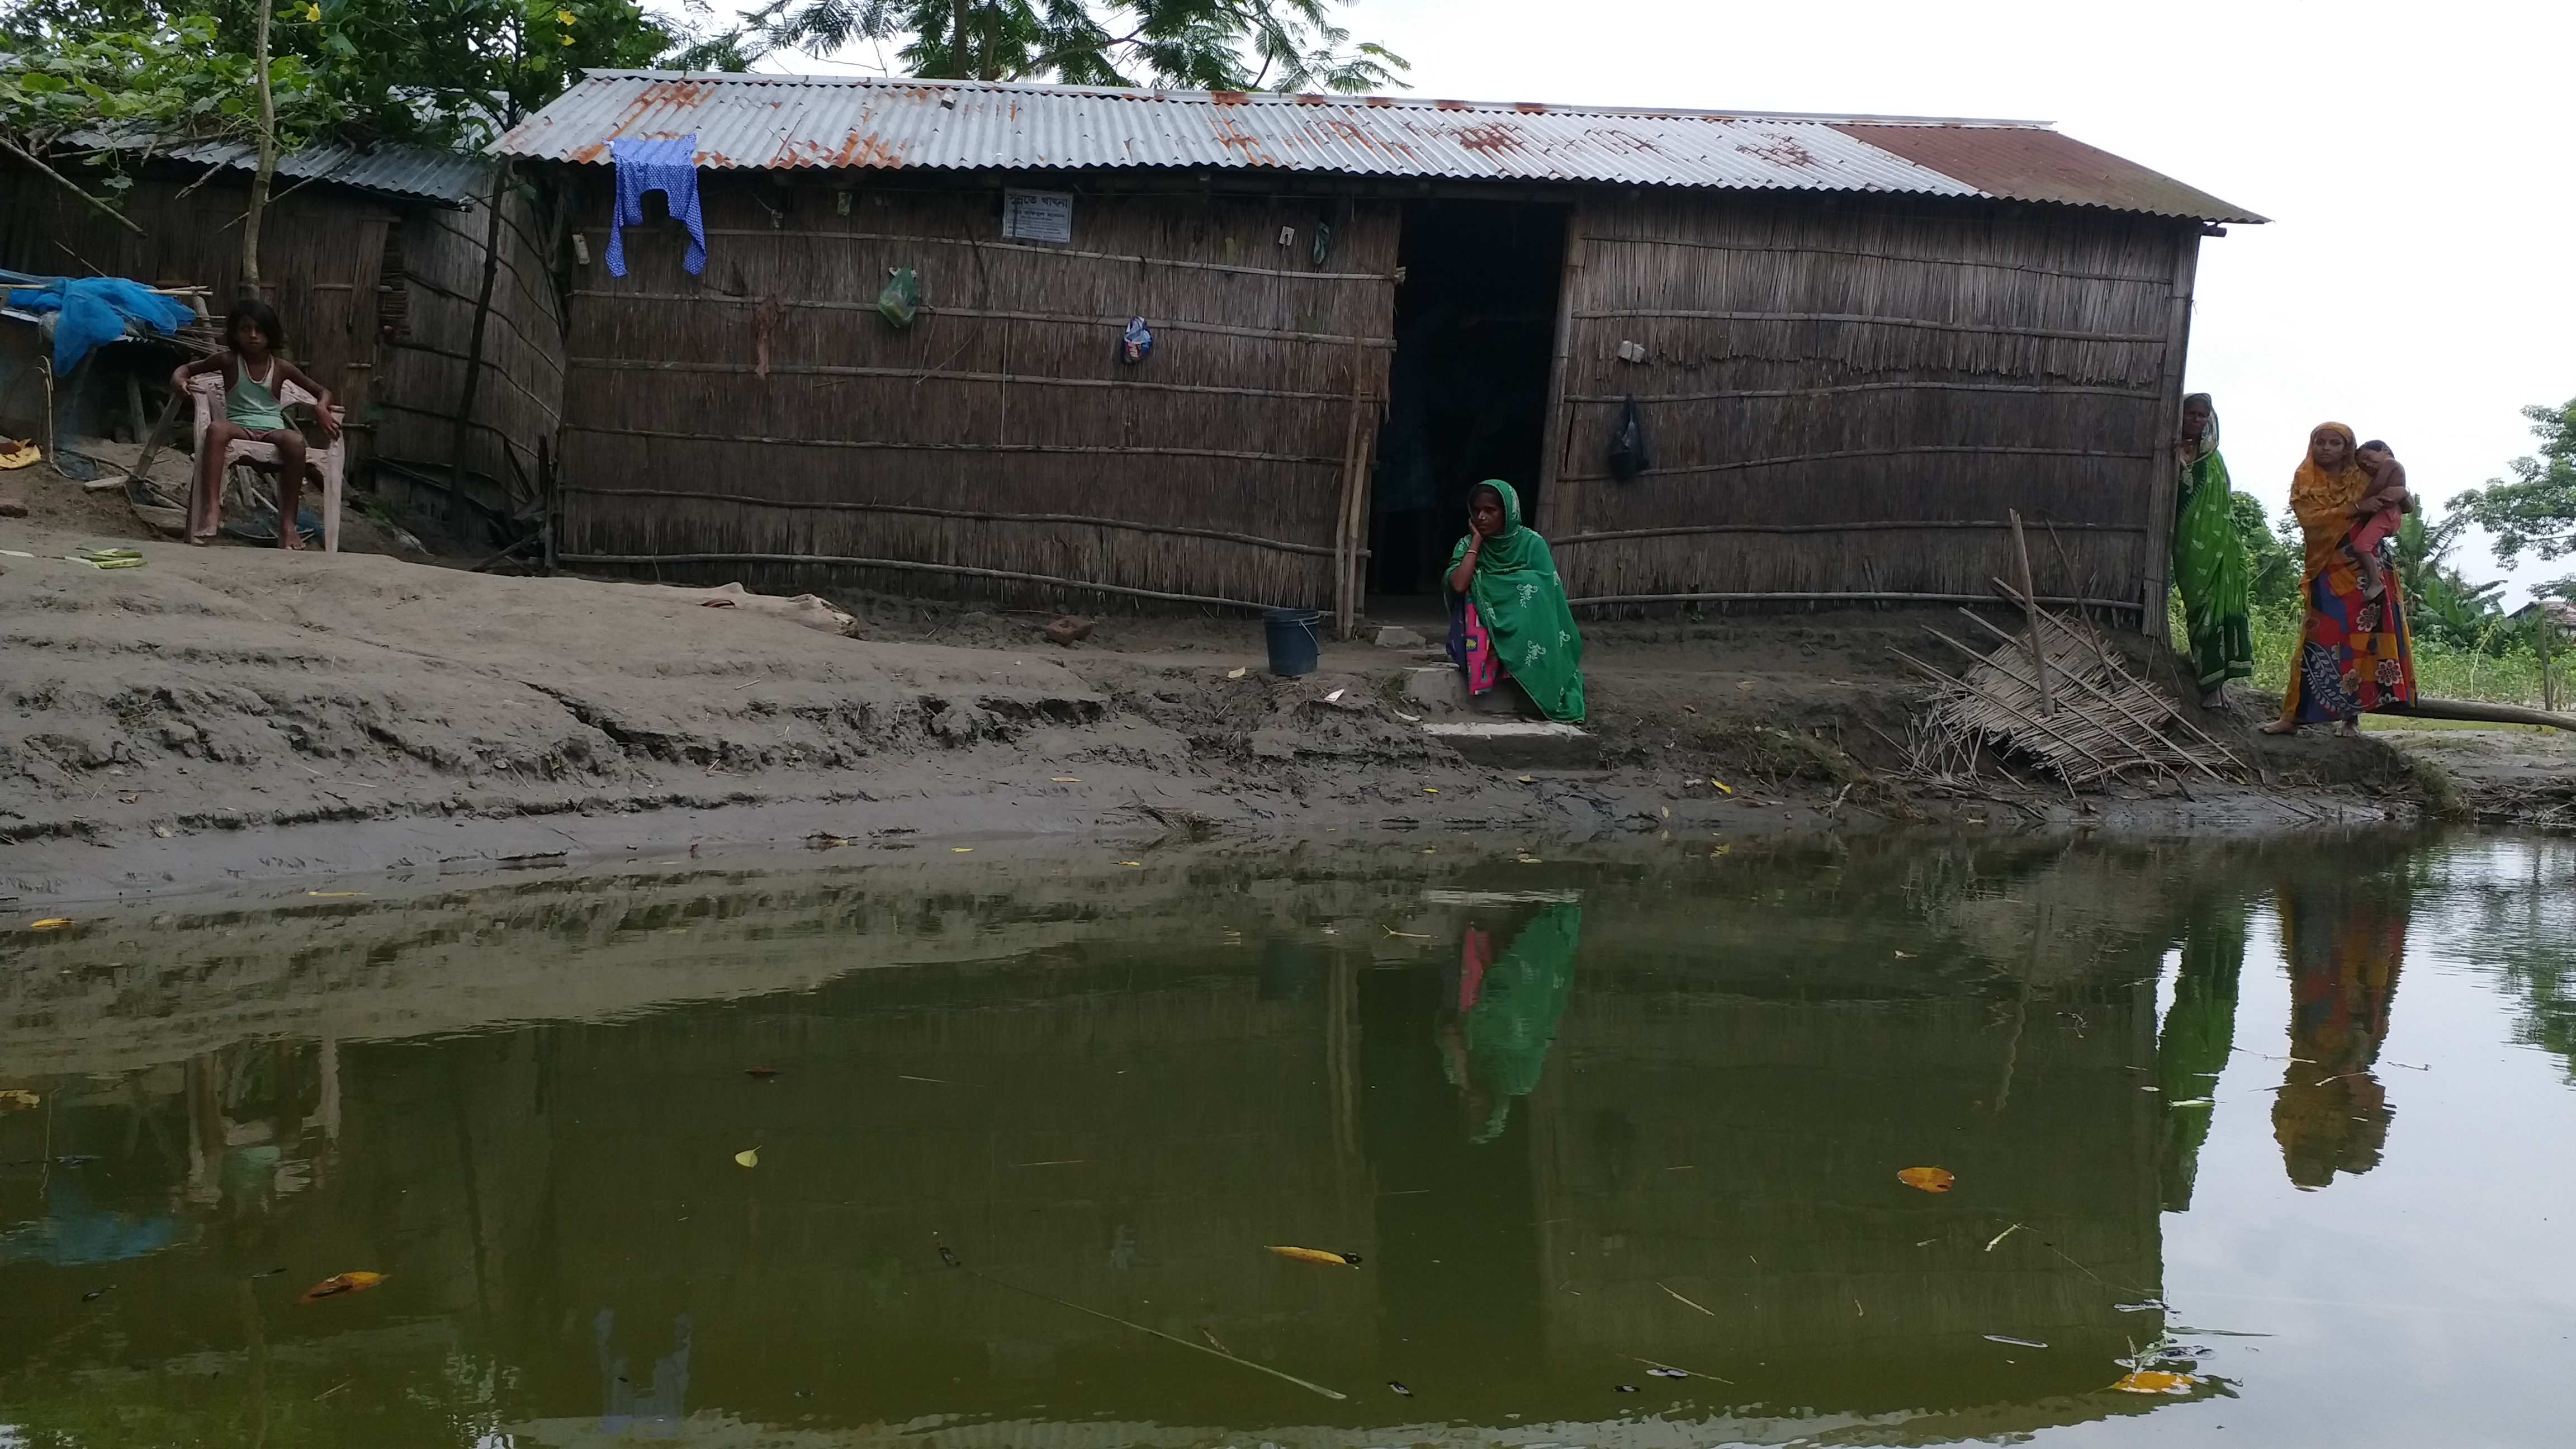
[373,167,564,513]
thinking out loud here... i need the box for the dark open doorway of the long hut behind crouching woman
[1368,201,1566,593]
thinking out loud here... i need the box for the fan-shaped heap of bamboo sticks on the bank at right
[1891,510,2251,789]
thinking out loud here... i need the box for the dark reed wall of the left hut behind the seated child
[0,165,394,394]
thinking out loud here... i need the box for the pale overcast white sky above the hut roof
[736,0,2576,603]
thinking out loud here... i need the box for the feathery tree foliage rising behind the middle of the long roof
[721,0,1409,93]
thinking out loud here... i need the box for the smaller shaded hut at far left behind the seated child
[0,142,564,536]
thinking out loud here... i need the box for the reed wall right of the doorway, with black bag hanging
[1541,191,2200,619]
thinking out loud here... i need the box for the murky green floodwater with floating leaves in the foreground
[0,835,2576,1449]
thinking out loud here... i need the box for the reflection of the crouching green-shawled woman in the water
[1440,902,1584,1142]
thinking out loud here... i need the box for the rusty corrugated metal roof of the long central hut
[492,70,2259,222]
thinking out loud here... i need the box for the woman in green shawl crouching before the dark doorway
[1445,477,1584,724]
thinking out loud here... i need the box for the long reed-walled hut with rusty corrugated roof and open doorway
[497,72,2259,627]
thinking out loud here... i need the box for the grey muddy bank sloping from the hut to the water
[0,503,2520,902]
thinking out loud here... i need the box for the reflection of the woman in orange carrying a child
[2272,877,2406,1191]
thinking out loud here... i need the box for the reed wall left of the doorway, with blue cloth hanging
[562,173,1396,606]
